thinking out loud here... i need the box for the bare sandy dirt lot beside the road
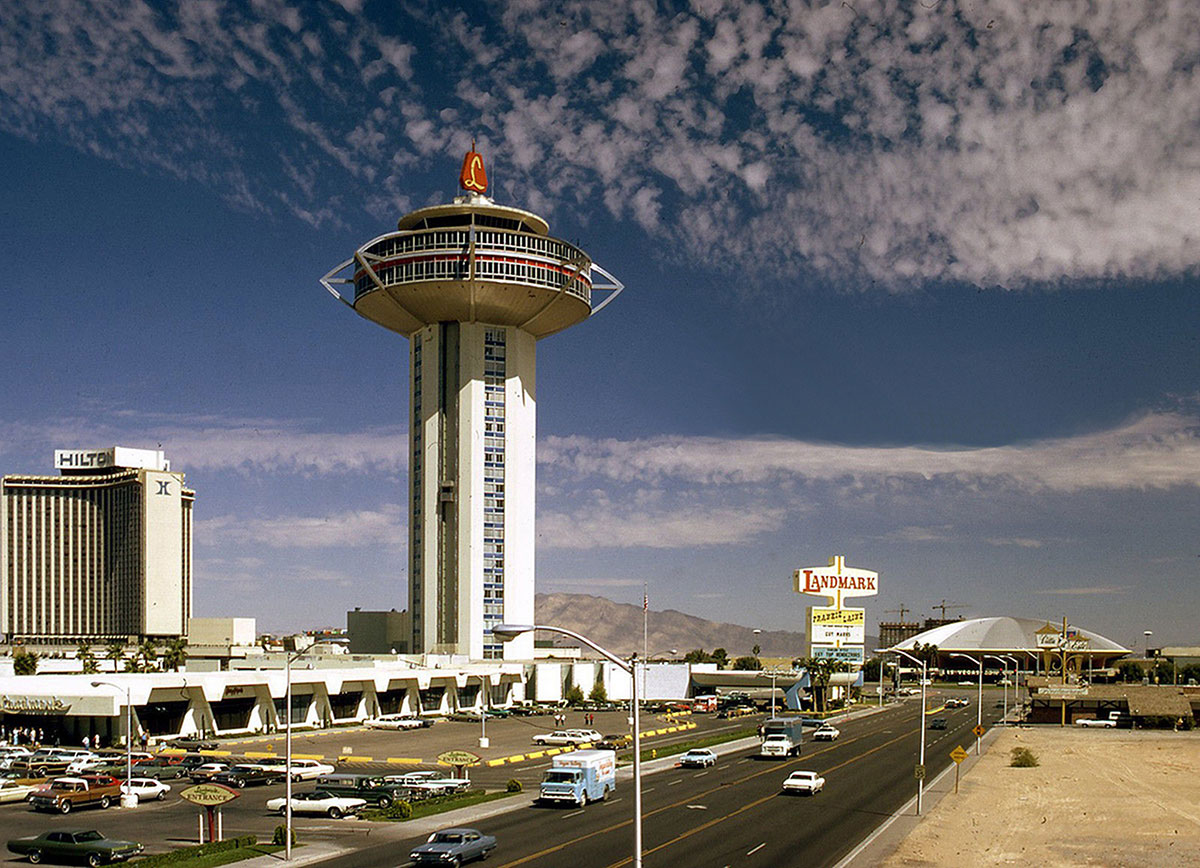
[883,726,1200,868]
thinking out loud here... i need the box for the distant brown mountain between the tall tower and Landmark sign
[534,594,811,659]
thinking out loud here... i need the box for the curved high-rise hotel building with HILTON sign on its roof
[0,447,196,643]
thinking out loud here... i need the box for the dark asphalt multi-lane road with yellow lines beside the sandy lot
[320,692,1000,868]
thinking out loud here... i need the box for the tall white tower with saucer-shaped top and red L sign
[320,148,624,659]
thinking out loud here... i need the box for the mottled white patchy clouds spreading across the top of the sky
[0,0,1200,289]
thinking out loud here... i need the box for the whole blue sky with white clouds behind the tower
[0,0,1200,647]
